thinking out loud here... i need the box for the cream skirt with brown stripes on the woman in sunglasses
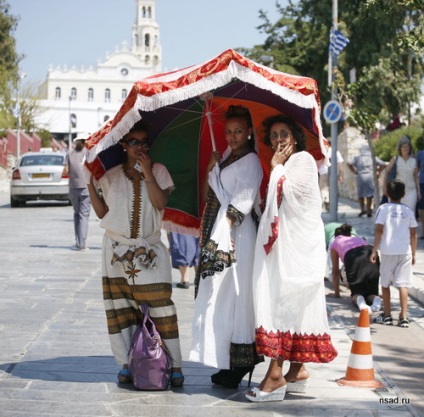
[103,237,182,368]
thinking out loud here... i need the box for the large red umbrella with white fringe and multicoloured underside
[86,49,326,234]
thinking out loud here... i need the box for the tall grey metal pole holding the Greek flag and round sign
[328,0,339,222]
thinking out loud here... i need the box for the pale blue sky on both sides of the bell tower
[8,0,285,82]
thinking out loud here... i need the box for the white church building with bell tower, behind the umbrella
[36,0,162,140]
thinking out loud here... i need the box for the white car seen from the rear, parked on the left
[10,151,70,207]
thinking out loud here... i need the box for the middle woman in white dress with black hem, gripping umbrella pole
[190,106,262,388]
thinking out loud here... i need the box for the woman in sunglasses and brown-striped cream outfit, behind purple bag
[88,121,184,387]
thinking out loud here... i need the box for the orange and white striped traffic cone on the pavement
[336,309,383,388]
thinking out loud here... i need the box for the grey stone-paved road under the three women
[0,186,424,417]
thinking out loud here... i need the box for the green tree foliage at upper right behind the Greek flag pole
[242,0,423,127]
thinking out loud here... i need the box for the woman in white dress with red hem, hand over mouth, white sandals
[246,115,337,401]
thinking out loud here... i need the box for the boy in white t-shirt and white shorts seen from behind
[370,180,418,327]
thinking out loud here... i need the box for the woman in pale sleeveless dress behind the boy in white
[383,136,421,213]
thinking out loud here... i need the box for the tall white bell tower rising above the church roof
[131,0,162,73]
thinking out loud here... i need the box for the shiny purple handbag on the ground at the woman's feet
[128,304,171,390]
